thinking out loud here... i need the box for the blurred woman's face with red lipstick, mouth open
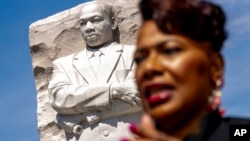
[134,21,221,120]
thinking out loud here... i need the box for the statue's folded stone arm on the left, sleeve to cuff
[49,62,110,114]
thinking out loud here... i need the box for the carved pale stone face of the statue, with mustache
[79,3,113,47]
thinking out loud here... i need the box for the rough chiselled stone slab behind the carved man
[29,0,141,141]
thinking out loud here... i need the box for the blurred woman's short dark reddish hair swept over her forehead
[139,0,227,52]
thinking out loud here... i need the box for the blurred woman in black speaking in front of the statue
[122,0,250,141]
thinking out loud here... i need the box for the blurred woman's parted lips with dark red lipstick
[145,84,174,107]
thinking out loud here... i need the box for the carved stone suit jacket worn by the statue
[49,43,142,141]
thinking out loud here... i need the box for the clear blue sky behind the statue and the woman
[0,0,250,141]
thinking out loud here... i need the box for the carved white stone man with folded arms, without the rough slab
[48,1,142,141]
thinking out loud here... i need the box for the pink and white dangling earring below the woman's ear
[207,79,223,112]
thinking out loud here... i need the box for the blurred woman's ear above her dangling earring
[211,53,224,88]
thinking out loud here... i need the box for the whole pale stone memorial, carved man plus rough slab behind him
[30,1,142,141]
